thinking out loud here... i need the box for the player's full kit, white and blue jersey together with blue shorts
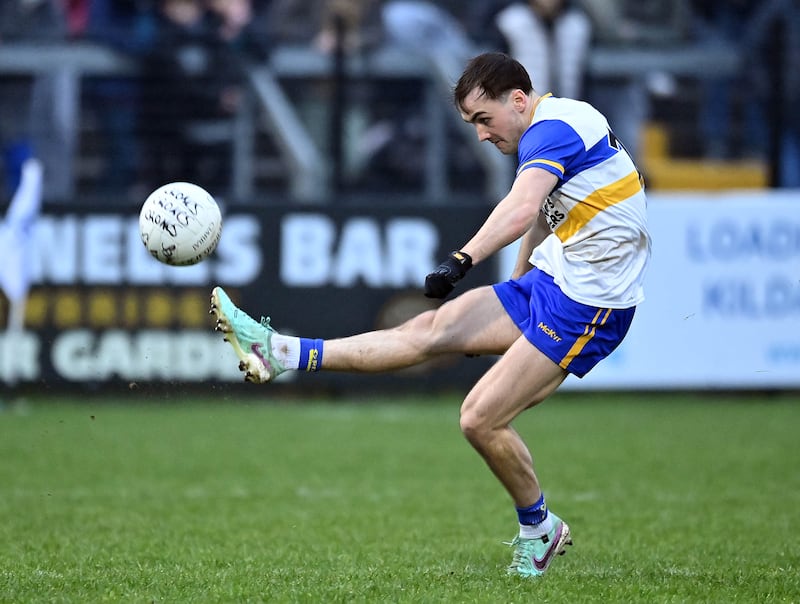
[494,95,650,377]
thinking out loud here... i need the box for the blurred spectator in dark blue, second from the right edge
[693,0,767,159]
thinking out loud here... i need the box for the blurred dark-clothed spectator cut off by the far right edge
[743,0,800,188]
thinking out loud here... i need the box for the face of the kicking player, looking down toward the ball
[461,88,529,155]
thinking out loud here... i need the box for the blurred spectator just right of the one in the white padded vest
[579,0,691,161]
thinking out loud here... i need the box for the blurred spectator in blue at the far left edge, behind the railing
[0,0,65,198]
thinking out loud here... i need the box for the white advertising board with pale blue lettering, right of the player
[501,191,800,389]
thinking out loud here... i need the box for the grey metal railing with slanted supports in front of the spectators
[0,40,740,203]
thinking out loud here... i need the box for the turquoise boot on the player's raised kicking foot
[209,287,287,384]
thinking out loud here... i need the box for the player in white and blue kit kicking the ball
[211,53,650,577]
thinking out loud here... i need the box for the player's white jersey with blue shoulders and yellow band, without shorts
[517,95,650,309]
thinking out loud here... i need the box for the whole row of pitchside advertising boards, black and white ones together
[0,192,800,393]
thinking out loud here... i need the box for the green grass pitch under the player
[0,387,800,603]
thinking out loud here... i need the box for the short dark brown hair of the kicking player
[453,52,533,110]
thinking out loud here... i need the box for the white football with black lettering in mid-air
[139,182,222,266]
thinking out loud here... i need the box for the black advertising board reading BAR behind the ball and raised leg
[0,205,496,388]
